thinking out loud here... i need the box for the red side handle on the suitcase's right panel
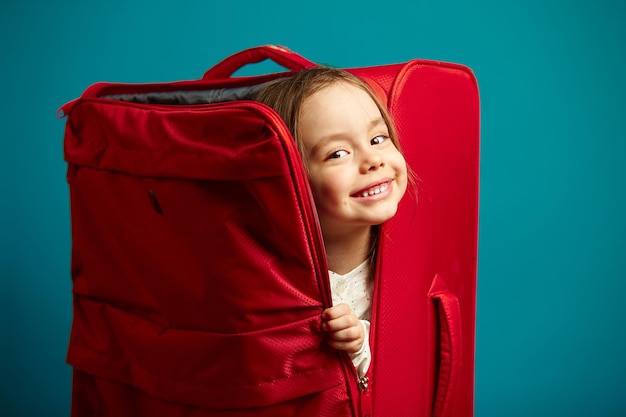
[429,274,462,417]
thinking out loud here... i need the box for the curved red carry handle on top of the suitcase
[202,45,317,80]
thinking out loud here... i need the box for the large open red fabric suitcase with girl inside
[60,46,479,417]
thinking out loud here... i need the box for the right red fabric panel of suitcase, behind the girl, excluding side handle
[355,60,479,417]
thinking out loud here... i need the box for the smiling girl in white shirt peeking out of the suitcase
[256,67,408,377]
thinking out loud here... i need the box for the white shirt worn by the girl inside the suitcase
[328,260,373,377]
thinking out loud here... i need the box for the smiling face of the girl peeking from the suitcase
[298,82,407,240]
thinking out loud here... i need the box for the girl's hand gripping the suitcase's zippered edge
[322,304,365,353]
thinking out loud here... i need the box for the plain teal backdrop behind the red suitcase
[0,0,626,417]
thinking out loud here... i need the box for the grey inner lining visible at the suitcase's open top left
[101,83,265,104]
